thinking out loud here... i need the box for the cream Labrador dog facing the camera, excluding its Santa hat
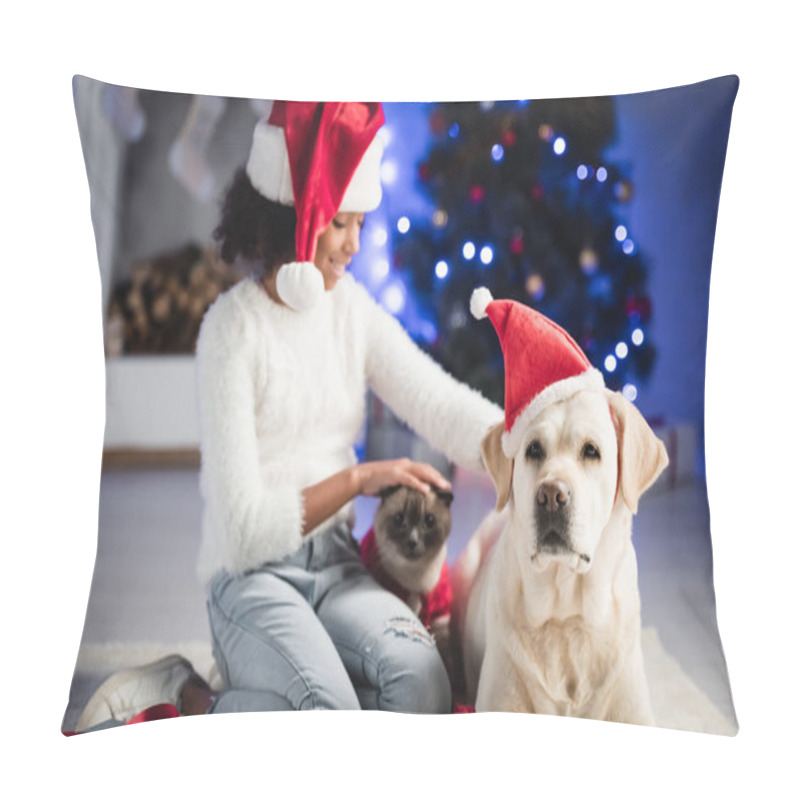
[453,389,667,724]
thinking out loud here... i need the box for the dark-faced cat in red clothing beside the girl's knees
[361,486,453,670]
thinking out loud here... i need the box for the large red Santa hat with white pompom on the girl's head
[246,100,384,309]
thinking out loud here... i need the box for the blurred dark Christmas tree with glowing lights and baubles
[392,98,655,404]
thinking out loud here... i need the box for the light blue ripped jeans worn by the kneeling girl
[207,525,451,713]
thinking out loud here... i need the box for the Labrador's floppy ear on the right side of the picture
[606,389,669,514]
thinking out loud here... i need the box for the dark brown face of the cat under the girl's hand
[375,486,453,561]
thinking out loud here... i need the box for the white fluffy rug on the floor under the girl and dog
[76,628,738,736]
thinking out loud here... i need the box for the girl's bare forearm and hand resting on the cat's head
[302,458,451,535]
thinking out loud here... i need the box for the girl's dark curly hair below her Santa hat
[213,168,297,275]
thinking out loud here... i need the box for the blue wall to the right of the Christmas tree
[609,78,738,429]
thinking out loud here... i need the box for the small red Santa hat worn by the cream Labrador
[470,287,604,458]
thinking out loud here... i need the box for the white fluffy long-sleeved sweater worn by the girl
[197,275,503,583]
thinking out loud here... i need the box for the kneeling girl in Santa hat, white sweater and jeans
[79,103,503,728]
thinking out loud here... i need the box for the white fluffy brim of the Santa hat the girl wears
[245,119,383,212]
